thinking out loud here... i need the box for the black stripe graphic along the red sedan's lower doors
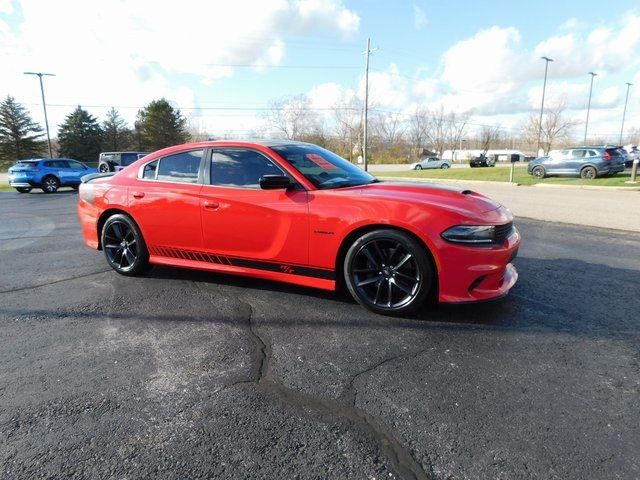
[149,246,335,280]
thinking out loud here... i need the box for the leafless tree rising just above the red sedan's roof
[264,95,322,140]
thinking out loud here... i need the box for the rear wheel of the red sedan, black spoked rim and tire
[100,214,150,276]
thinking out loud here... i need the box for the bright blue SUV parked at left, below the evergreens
[9,158,97,193]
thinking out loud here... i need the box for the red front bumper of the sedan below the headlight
[439,228,520,303]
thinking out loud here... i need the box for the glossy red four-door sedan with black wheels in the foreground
[78,141,520,315]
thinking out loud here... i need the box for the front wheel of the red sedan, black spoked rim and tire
[343,229,434,316]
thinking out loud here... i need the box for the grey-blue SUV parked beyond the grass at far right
[527,147,624,179]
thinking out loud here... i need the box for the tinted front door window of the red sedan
[211,148,285,188]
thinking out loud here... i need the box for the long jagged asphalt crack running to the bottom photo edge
[227,298,433,480]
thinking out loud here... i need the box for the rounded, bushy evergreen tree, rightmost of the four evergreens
[136,98,189,151]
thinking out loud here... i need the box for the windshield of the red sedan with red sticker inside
[271,145,378,189]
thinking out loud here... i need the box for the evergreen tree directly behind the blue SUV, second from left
[58,106,102,162]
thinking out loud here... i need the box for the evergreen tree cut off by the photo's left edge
[0,95,45,161]
